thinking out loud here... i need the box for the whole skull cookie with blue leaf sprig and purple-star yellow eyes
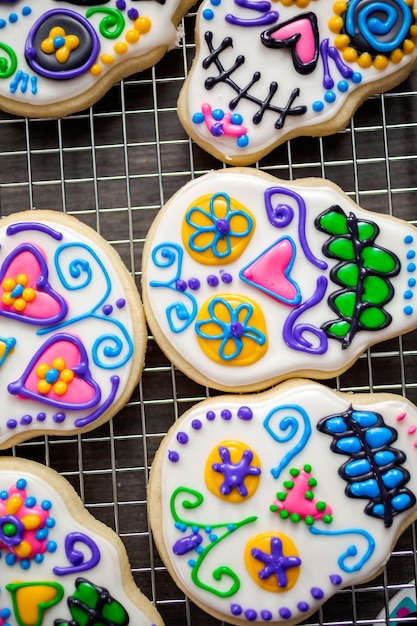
[149,379,417,626]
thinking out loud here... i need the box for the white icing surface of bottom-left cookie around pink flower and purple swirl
[0,458,162,626]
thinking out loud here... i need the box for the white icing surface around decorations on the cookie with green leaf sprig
[143,169,417,391]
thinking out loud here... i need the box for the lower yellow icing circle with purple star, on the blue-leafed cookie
[245,532,301,593]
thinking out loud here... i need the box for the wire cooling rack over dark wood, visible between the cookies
[0,3,417,626]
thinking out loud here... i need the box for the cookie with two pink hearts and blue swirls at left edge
[0,211,146,448]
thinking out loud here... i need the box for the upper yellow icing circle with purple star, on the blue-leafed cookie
[205,441,261,504]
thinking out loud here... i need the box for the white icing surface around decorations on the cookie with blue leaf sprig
[149,380,417,624]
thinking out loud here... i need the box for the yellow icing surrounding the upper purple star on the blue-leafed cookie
[204,441,261,504]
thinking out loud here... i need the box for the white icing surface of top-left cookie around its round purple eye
[0,0,190,116]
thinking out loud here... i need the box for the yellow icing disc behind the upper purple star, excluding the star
[205,441,261,504]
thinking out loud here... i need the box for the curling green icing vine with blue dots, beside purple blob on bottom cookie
[170,487,258,598]
